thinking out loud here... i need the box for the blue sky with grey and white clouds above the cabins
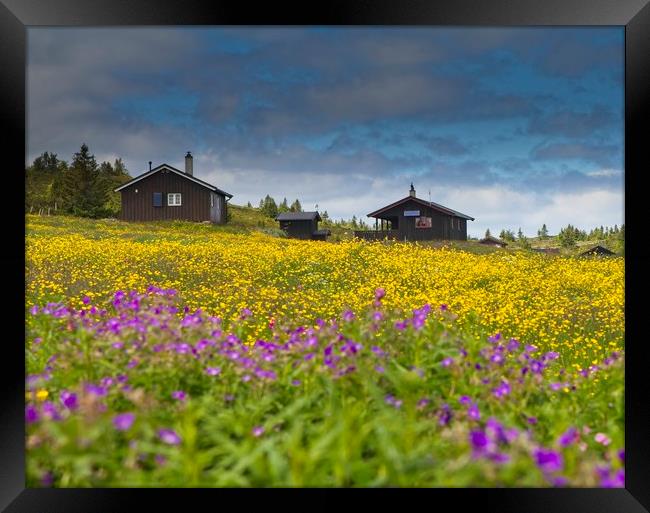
[27,27,624,236]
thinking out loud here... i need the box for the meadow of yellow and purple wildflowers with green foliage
[26,217,624,487]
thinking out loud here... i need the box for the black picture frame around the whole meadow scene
[0,0,650,513]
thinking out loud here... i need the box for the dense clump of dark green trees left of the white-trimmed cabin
[25,143,131,218]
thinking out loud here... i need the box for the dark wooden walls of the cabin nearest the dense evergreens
[120,169,210,221]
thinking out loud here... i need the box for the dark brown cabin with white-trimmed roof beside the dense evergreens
[115,151,232,224]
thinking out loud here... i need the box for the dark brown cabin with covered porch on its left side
[354,184,474,241]
